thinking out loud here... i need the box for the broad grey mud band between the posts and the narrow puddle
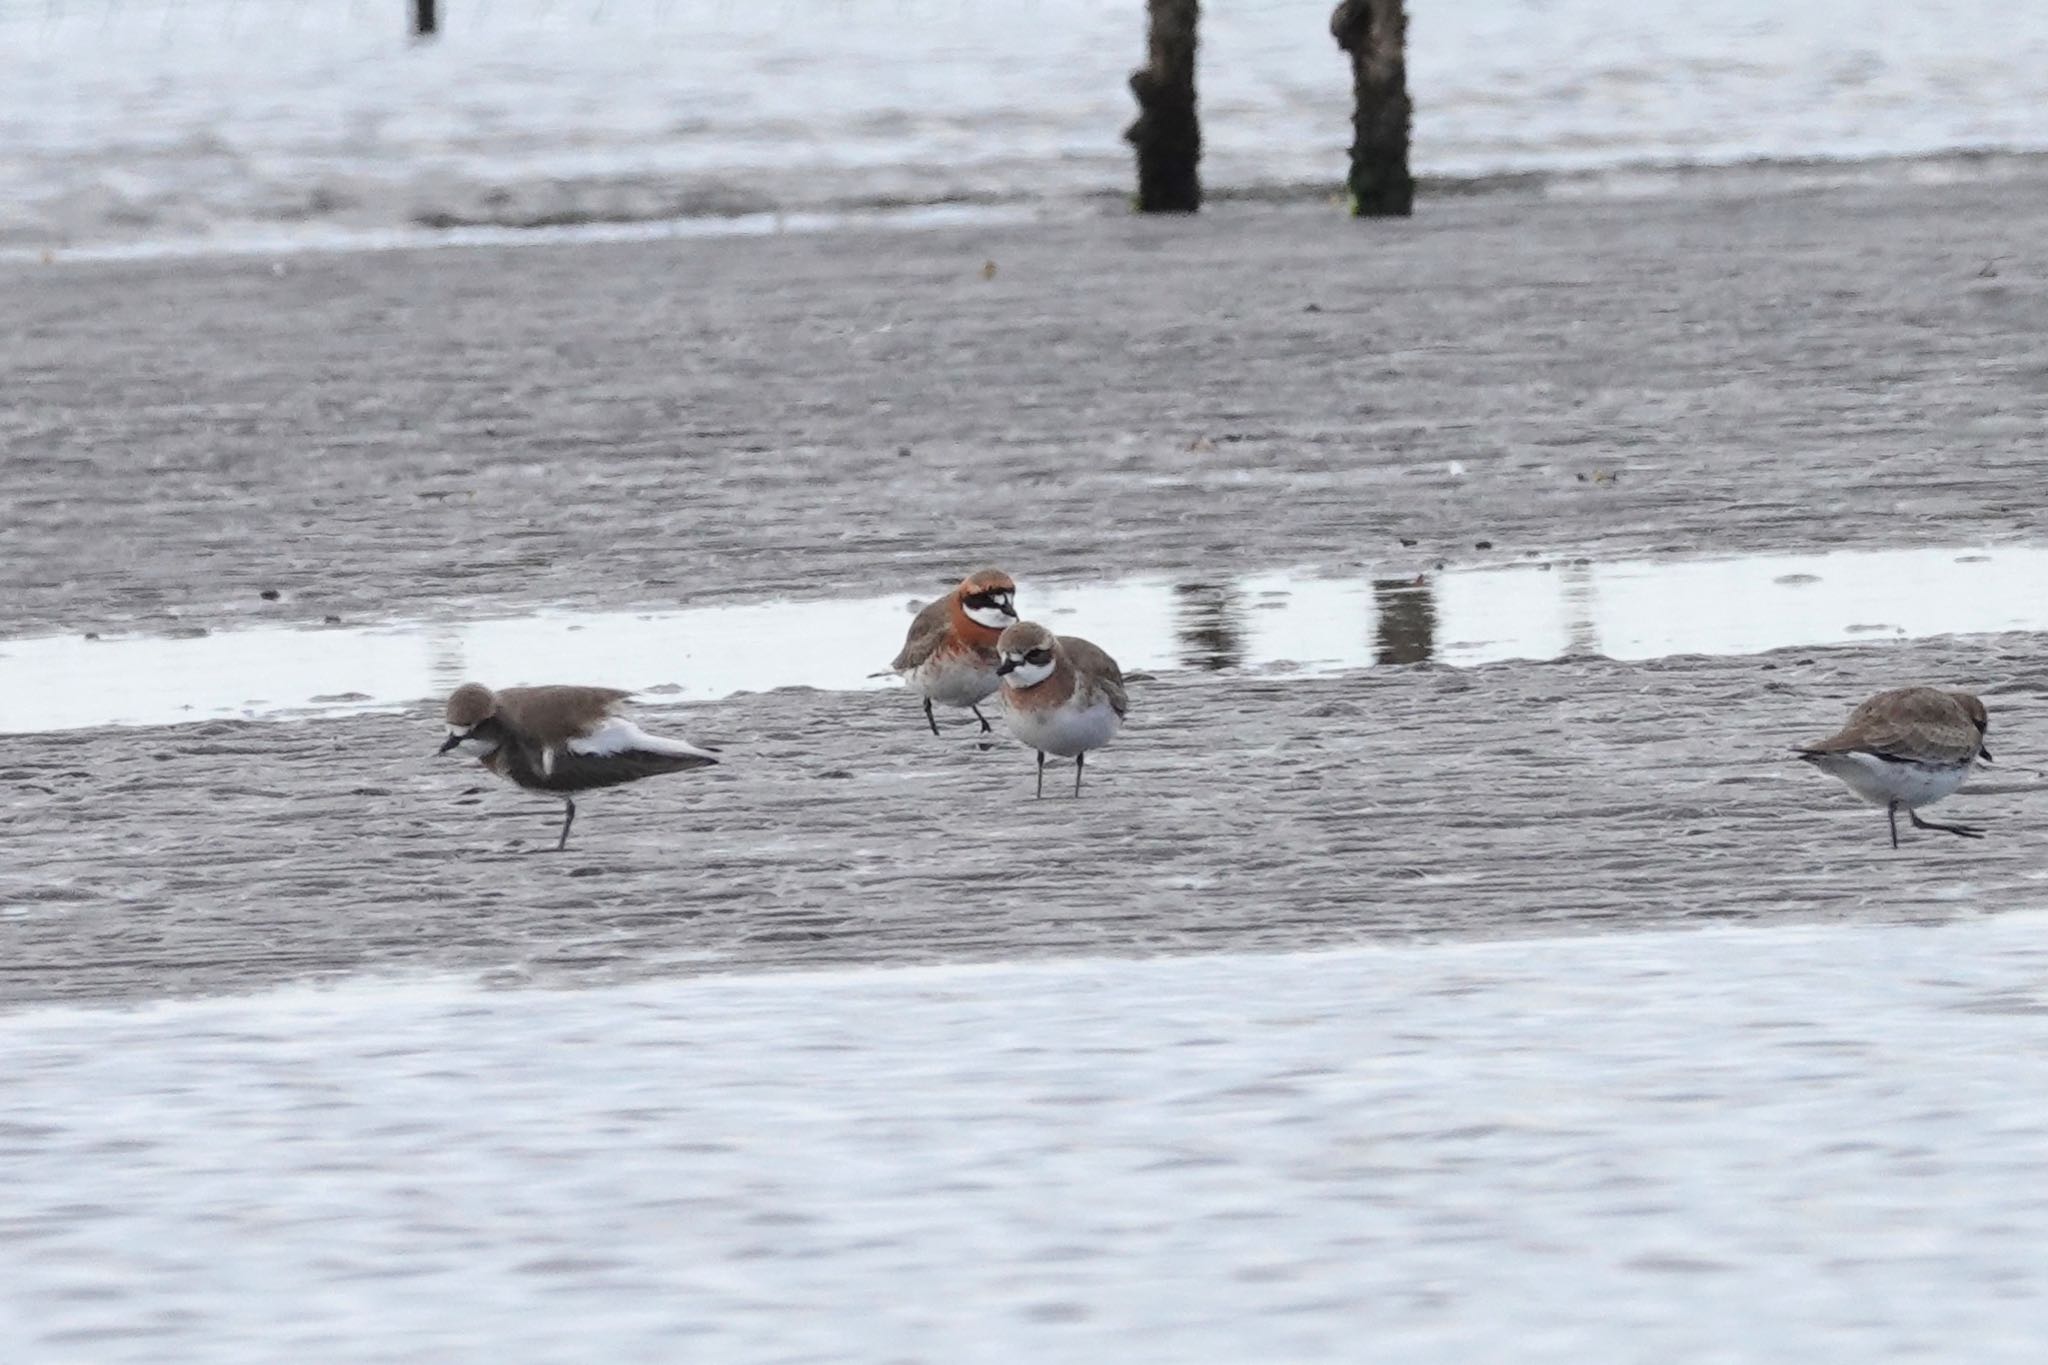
[0,178,2048,634]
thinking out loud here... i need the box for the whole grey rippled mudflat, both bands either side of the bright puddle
[0,178,2048,1003]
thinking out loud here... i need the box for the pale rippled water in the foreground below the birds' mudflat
[0,915,2048,1365]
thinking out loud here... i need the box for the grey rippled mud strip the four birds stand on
[0,636,2048,1005]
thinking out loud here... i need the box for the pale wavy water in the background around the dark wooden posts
[12,0,2048,252]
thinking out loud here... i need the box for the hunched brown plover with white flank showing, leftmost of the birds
[440,684,719,853]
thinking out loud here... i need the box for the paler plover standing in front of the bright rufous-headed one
[995,620,1130,796]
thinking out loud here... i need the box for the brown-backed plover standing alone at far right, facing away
[1794,688,1991,849]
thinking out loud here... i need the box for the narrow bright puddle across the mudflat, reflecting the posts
[0,546,2048,733]
